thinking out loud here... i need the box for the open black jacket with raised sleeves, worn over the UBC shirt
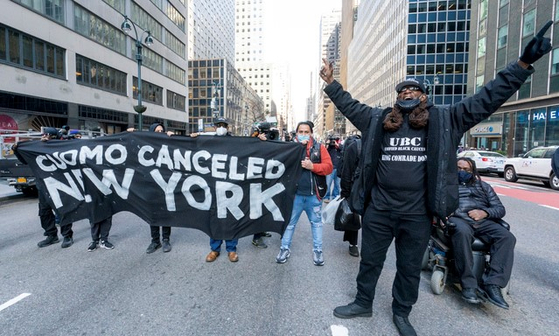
[324,62,534,218]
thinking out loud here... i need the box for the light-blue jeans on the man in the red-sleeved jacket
[281,195,322,251]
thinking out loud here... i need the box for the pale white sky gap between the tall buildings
[265,0,342,121]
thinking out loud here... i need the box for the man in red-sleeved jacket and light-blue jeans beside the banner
[276,121,334,266]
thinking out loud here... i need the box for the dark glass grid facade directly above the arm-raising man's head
[406,0,471,105]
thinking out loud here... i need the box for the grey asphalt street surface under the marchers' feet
[0,176,559,336]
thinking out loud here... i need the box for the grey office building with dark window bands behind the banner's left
[0,0,188,133]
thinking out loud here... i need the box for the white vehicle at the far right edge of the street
[505,146,559,190]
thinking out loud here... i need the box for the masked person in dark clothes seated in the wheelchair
[448,158,516,309]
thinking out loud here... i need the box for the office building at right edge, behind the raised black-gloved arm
[466,0,559,157]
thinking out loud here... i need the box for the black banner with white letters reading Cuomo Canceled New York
[18,132,304,239]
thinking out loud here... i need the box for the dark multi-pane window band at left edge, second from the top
[0,25,66,78]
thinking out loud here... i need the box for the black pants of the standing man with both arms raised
[355,207,431,317]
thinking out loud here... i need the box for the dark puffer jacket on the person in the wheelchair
[453,179,506,224]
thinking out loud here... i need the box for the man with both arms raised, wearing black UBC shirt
[320,21,553,335]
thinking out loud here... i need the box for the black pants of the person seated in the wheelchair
[451,217,516,288]
